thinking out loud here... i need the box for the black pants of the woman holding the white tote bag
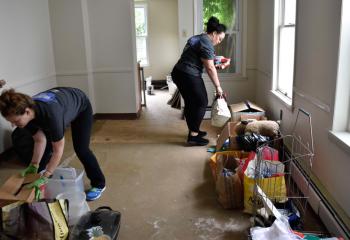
[171,68,208,132]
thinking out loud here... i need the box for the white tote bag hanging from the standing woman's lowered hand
[211,97,231,127]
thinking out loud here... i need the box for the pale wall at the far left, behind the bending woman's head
[0,0,56,152]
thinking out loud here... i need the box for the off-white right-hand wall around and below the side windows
[256,0,350,221]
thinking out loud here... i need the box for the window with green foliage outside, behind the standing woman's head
[198,0,242,73]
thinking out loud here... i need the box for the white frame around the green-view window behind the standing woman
[194,0,247,80]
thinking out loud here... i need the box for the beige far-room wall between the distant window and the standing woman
[145,0,179,80]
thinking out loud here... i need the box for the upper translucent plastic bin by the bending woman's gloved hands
[45,168,84,199]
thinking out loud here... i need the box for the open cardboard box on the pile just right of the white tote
[230,101,265,122]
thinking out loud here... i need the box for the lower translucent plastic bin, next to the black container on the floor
[56,191,90,226]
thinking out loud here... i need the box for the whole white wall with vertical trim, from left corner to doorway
[50,0,139,113]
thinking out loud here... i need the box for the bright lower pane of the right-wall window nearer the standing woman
[277,27,295,97]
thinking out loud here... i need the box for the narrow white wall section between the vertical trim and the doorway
[88,0,138,113]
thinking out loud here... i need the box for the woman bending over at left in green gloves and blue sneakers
[0,87,106,201]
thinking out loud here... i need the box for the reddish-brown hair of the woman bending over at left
[0,89,35,117]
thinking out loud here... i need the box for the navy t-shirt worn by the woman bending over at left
[25,87,90,142]
